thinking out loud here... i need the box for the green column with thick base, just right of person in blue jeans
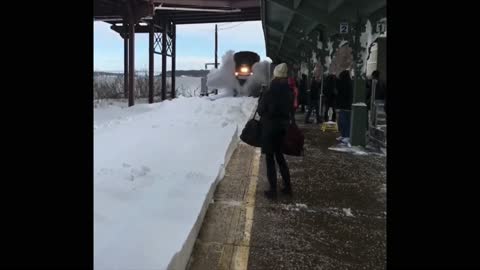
[350,16,367,146]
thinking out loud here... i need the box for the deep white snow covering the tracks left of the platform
[94,97,257,270]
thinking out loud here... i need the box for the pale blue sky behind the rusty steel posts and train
[93,21,266,74]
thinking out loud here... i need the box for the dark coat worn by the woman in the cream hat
[258,79,294,153]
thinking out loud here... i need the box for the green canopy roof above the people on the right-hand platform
[261,0,387,61]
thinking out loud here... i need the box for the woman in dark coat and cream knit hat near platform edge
[258,63,294,198]
